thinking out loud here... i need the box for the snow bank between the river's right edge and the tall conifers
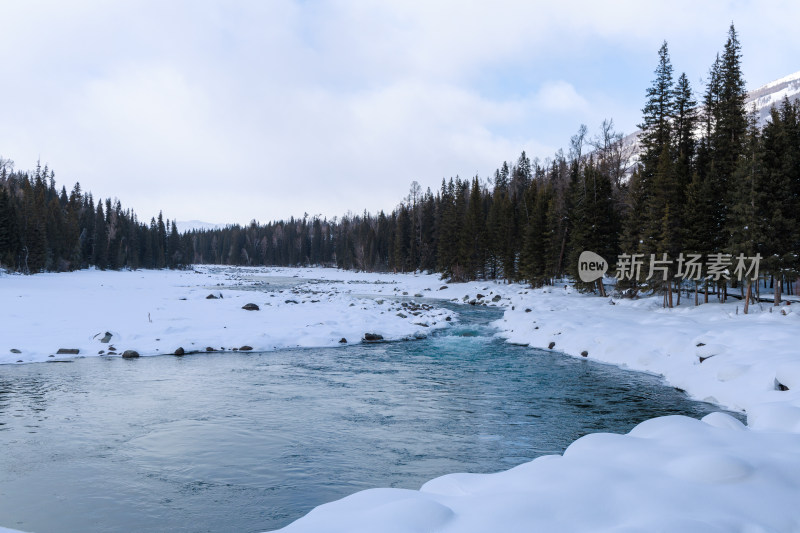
[496,289,800,431]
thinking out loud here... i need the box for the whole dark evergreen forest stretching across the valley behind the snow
[0,25,800,306]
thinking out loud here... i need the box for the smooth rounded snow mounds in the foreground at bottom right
[281,413,800,533]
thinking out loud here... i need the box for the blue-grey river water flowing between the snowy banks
[0,307,736,533]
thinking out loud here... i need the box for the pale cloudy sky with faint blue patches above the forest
[0,0,800,223]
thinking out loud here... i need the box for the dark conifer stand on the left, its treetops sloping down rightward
[0,158,186,274]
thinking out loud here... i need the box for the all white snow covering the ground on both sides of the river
[0,267,800,533]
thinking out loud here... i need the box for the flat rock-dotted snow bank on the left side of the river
[0,267,455,363]
